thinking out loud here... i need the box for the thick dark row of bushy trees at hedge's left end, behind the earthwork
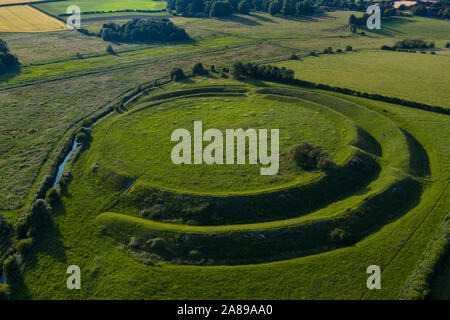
[232,61,294,82]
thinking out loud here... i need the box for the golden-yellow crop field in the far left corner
[0,5,66,32]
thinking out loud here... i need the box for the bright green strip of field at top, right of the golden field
[36,0,166,16]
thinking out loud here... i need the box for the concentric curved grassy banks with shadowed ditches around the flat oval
[87,82,426,265]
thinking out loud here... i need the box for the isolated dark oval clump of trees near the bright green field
[98,18,189,42]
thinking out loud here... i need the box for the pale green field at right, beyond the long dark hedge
[278,50,450,108]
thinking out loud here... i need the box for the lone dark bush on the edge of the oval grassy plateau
[291,142,335,170]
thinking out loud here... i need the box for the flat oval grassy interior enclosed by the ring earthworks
[91,91,355,194]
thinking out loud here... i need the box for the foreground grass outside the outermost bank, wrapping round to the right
[12,79,449,299]
